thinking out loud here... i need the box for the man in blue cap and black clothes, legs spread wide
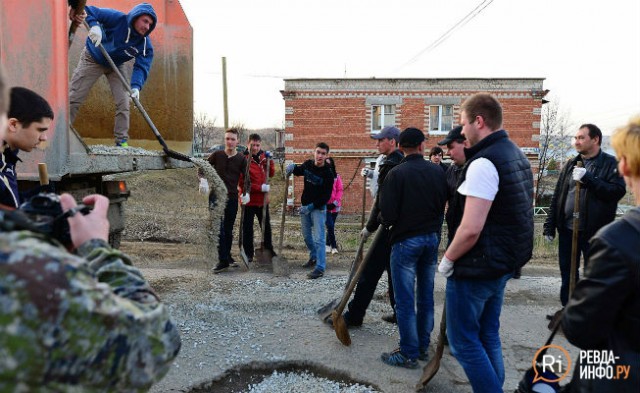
[327,126,404,326]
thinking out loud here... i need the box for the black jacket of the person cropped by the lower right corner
[562,207,640,393]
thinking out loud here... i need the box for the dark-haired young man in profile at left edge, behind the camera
[0,87,53,208]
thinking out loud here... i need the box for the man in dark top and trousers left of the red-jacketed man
[208,128,251,274]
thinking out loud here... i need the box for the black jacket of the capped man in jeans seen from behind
[380,154,447,244]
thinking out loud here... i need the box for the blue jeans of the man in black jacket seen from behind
[391,232,438,359]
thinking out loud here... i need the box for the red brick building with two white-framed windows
[281,78,546,213]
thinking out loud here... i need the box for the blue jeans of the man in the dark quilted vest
[446,273,511,393]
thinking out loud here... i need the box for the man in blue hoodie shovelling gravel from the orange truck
[69,3,158,147]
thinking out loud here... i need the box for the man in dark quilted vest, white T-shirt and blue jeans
[438,94,533,393]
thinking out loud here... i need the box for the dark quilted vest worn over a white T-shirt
[453,130,533,279]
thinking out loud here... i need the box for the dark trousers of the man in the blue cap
[347,226,396,323]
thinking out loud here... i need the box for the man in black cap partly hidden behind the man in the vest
[438,126,467,245]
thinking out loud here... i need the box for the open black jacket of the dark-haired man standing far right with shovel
[544,150,625,239]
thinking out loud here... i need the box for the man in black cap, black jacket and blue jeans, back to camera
[379,128,447,368]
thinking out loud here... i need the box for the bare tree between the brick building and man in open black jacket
[535,100,571,205]
